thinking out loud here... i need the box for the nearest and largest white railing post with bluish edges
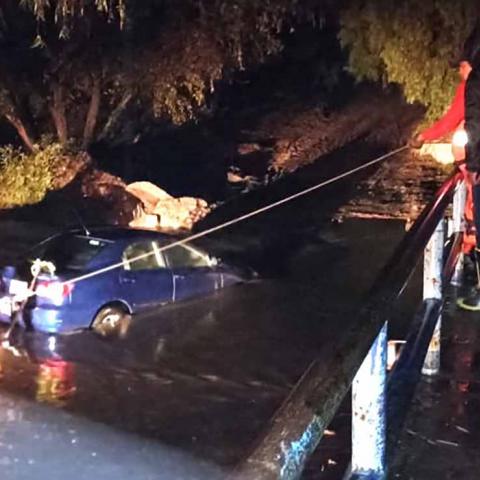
[350,323,387,480]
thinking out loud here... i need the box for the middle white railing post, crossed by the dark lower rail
[422,219,445,375]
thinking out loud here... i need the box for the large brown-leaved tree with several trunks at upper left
[0,0,327,151]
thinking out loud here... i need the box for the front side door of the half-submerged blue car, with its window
[164,244,222,301]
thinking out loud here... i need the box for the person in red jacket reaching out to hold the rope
[410,57,476,254]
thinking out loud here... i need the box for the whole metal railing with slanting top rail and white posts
[233,173,465,480]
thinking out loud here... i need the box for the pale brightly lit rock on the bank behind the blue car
[126,182,210,232]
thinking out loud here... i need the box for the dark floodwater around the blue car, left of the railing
[0,220,418,480]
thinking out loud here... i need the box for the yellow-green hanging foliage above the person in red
[339,0,478,120]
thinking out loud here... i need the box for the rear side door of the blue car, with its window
[119,240,173,311]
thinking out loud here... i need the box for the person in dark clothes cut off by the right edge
[457,28,480,311]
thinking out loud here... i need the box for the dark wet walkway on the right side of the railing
[391,291,480,480]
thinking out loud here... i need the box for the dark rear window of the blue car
[38,235,109,273]
